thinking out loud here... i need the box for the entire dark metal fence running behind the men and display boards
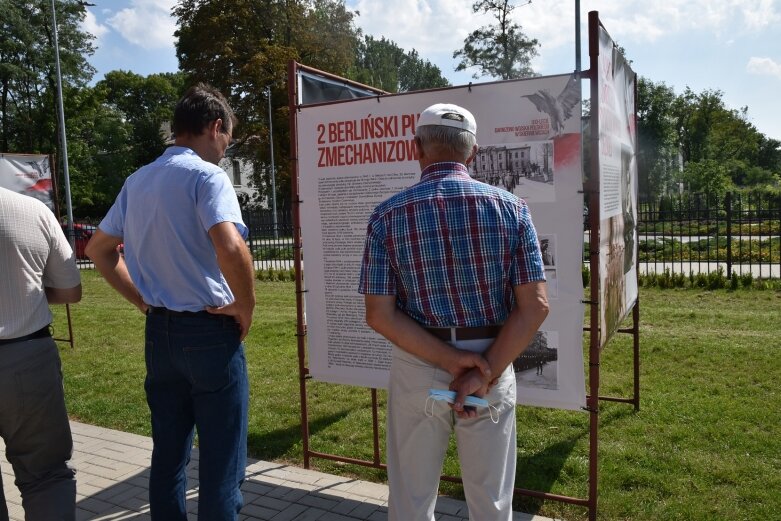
[74,193,781,279]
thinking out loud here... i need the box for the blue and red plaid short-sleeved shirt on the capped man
[359,163,545,327]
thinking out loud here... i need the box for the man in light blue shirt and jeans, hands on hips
[86,84,255,521]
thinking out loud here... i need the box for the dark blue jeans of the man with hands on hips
[144,313,249,521]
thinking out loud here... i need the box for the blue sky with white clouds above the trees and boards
[84,0,781,140]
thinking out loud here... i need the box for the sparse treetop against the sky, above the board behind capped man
[453,0,539,80]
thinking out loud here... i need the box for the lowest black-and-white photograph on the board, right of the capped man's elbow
[513,330,559,389]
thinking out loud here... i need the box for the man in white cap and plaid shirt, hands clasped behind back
[359,104,548,521]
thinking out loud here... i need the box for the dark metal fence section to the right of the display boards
[637,193,781,279]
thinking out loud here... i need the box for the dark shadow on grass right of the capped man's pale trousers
[513,402,635,514]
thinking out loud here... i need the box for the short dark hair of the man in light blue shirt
[172,83,238,136]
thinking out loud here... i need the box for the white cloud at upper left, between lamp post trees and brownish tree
[107,0,176,50]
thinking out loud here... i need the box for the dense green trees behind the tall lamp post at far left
[0,0,183,219]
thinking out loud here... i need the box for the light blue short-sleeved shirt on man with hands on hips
[100,146,247,311]
